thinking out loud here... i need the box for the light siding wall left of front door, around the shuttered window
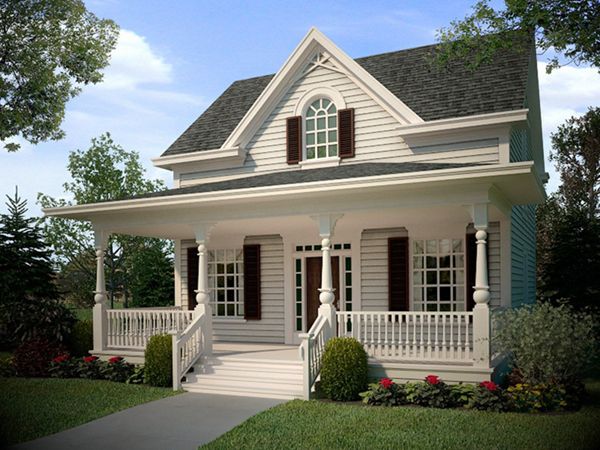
[180,236,284,343]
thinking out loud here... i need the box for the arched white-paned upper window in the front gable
[305,98,338,160]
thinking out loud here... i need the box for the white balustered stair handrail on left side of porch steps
[170,313,205,391]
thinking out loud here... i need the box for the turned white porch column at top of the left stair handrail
[194,224,213,355]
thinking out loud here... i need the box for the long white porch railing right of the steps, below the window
[337,311,473,362]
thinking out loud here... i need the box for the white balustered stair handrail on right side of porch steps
[299,315,331,400]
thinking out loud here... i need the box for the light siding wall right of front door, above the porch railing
[360,222,501,311]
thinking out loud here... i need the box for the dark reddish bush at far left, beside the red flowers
[14,339,65,377]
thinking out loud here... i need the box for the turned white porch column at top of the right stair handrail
[315,214,342,339]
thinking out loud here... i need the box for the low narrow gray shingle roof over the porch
[129,163,479,199]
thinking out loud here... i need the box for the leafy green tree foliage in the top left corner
[0,0,118,151]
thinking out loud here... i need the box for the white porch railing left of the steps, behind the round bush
[106,309,194,350]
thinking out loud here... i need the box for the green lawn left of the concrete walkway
[0,378,174,448]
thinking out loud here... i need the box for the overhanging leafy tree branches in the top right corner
[436,0,600,73]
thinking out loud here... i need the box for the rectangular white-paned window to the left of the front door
[208,249,244,317]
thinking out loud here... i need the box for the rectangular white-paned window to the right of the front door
[413,239,465,311]
